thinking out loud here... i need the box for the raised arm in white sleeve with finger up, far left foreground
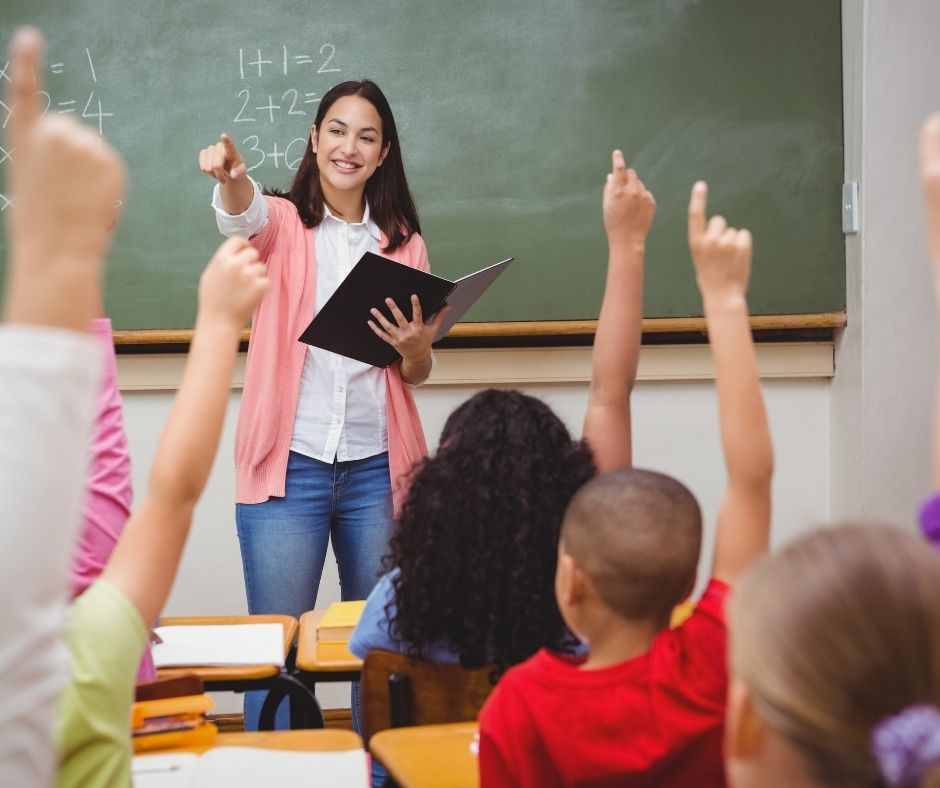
[0,28,124,786]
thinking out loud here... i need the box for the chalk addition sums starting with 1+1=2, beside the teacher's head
[232,42,342,172]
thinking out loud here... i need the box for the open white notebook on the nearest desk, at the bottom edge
[132,747,368,788]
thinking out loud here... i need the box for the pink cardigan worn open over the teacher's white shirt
[235,197,429,514]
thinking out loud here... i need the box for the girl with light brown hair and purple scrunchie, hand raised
[726,115,940,788]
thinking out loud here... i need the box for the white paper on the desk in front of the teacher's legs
[153,624,284,668]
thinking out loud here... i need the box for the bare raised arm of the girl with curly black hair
[583,150,656,473]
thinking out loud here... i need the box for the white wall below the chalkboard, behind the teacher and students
[122,349,829,711]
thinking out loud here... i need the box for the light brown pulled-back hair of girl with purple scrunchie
[731,526,940,787]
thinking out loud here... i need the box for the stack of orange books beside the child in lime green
[131,676,219,752]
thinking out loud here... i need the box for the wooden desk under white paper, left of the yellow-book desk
[151,615,324,731]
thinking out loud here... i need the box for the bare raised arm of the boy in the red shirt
[689,182,773,584]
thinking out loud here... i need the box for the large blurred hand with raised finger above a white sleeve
[5,23,125,330]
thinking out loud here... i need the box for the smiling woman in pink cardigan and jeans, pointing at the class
[199,81,443,728]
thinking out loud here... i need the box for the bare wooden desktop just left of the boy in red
[369,722,480,788]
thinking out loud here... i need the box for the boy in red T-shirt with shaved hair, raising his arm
[480,183,773,788]
